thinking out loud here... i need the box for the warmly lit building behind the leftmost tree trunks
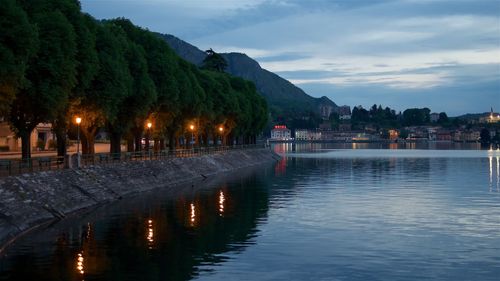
[0,122,55,151]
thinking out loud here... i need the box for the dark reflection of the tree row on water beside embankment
[0,173,268,281]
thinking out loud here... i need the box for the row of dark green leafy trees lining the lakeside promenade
[0,0,268,158]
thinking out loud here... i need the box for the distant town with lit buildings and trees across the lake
[269,105,500,145]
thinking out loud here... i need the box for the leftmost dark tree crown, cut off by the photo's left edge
[0,0,38,116]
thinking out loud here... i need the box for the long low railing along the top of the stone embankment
[0,145,264,177]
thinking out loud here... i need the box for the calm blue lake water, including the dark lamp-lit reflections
[0,144,500,281]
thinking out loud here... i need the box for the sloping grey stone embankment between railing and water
[0,149,279,249]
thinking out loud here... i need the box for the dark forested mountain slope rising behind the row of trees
[158,34,338,117]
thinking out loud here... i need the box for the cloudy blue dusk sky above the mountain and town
[81,0,500,116]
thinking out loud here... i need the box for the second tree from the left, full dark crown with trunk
[9,1,77,159]
